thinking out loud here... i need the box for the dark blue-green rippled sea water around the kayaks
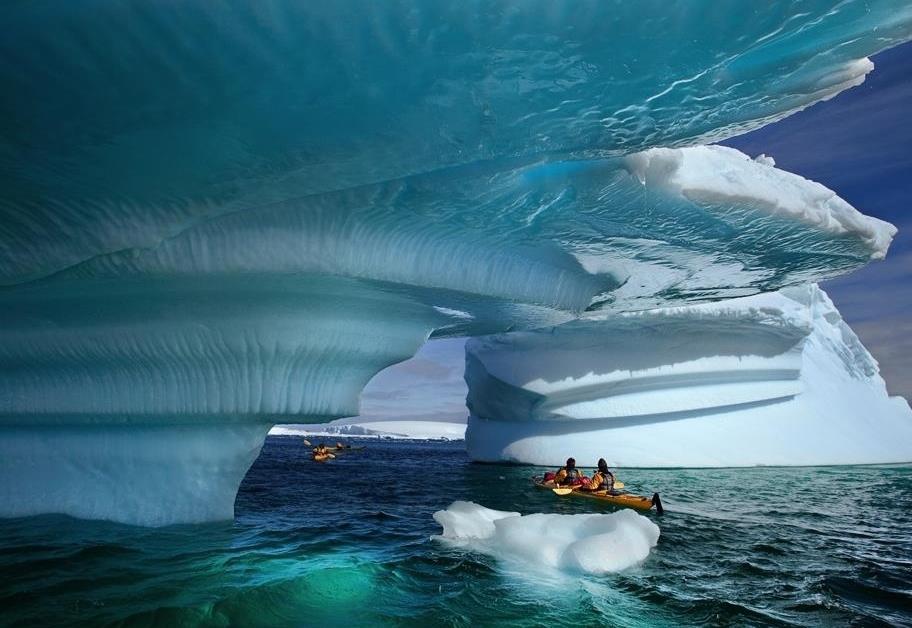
[0,437,912,627]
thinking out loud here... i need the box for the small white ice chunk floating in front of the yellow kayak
[433,501,659,574]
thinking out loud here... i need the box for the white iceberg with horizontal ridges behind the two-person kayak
[466,285,912,467]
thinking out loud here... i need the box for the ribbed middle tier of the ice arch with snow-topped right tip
[0,147,895,422]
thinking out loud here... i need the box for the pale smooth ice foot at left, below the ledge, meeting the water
[0,421,270,526]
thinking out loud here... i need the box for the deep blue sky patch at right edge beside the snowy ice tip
[725,44,912,399]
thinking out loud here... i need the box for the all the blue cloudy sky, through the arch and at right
[361,43,912,420]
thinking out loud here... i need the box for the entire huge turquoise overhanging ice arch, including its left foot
[0,0,912,524]
